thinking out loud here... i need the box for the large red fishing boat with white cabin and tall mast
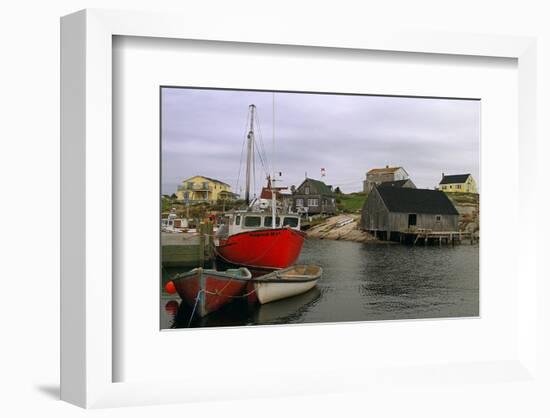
[216,105,305,269]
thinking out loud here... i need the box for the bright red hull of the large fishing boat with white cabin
[217,228,304,269]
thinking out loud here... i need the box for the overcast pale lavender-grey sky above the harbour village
[161,88,480,198]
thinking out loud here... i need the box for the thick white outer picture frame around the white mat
[61,10,548,408]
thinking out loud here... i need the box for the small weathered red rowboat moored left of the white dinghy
[172,267,252,317]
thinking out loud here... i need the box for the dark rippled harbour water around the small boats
[160,238,479,329]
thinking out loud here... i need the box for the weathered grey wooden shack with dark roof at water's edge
[361,186,458,240]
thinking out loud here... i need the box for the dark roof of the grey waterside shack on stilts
[376,186,458,215]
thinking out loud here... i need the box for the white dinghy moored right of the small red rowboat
[252,264,323,304]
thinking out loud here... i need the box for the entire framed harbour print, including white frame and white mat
[61,7,541,407]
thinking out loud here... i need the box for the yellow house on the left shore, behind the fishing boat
[176,176,235,203]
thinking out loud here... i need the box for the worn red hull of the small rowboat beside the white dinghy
[174,271,248,317]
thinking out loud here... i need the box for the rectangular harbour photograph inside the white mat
[159,85,484,329]
